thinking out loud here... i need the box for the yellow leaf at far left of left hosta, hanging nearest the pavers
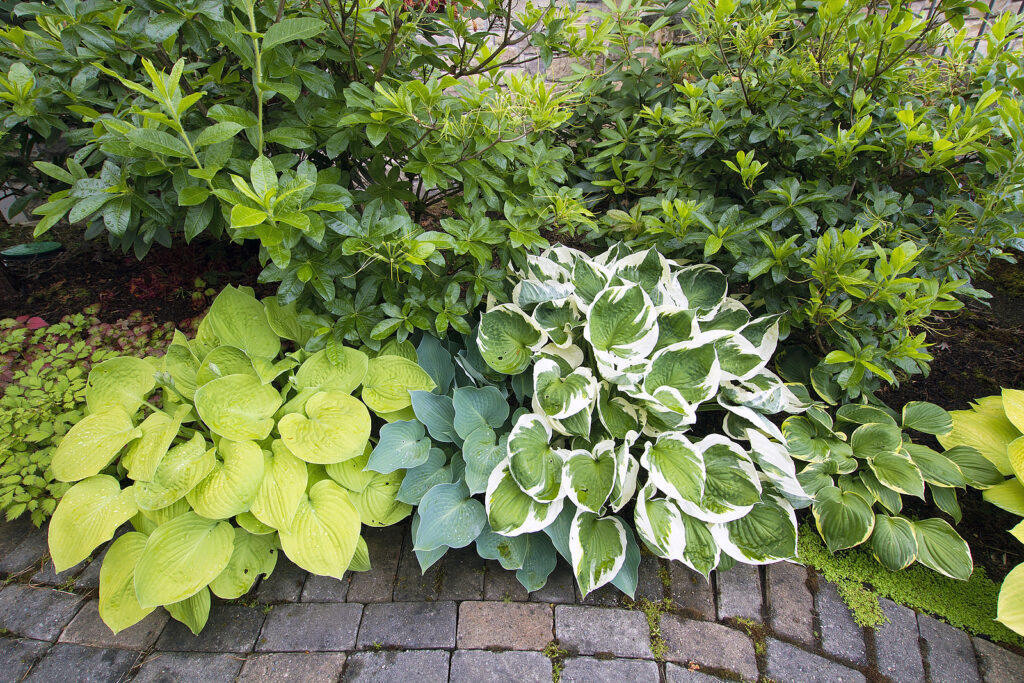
[48,474,138,571]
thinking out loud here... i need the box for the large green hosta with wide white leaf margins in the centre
[477,247,808,594]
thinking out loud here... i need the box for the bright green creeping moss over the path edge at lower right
[798,523,1024,646]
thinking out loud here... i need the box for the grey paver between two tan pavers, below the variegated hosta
[555,605,654,659]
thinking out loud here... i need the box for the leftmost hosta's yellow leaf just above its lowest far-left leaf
[50,407,142,481]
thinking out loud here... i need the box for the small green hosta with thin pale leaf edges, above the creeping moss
[782,401,1001,581]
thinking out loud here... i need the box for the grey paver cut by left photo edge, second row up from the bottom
[0,585,85,640]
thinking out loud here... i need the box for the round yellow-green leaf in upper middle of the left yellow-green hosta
[196,375,283,441]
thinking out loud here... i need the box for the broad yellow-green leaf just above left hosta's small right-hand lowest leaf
[135,512,234,607]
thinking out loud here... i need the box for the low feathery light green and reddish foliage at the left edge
[0,309,171,526]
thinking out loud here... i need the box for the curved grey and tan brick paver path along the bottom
[0,523,1024,683]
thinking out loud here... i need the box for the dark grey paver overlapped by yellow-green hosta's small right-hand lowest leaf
[157,605,263,652]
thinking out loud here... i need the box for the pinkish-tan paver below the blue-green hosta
[459,600,553,650]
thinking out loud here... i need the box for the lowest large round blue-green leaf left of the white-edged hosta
[416,483,487,550]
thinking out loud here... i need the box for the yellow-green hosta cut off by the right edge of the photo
[939,389,1024,635]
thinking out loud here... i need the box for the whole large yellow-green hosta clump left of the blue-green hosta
[49,287,434,633]
